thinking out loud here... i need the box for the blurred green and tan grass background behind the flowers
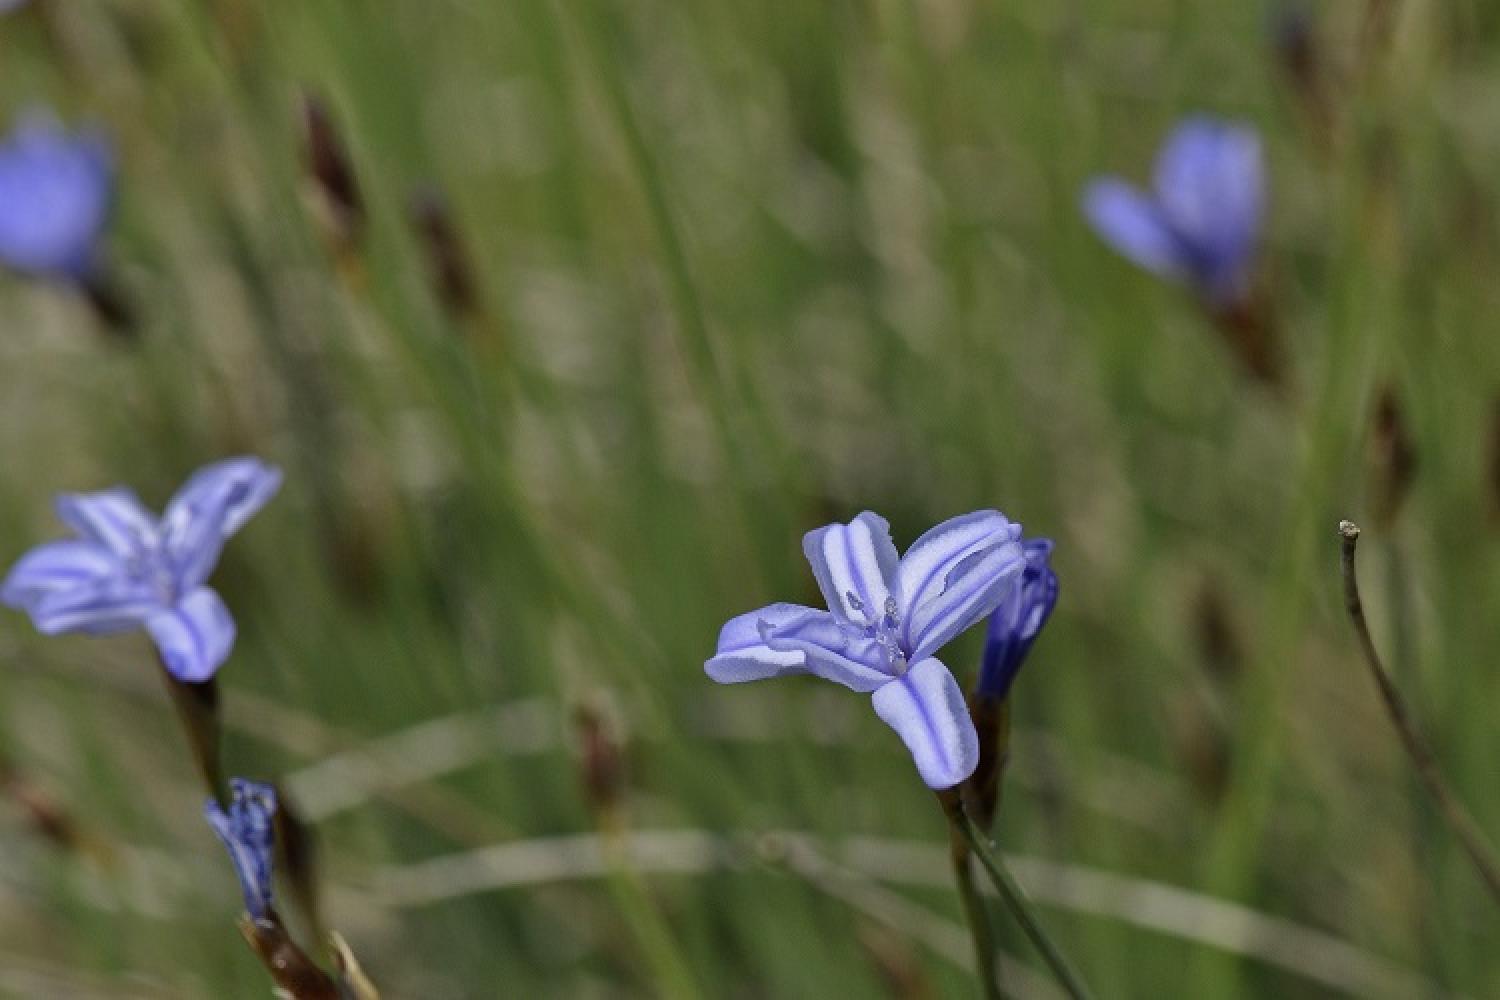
[0,0,1500,999]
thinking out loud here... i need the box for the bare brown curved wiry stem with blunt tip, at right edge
[1338,520,1500,903]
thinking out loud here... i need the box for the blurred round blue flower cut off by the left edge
[0,112,114,282]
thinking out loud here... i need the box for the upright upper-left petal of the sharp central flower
[803,511,902,625]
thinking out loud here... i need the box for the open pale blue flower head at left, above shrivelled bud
[0,457,281,684]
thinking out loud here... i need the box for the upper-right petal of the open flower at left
[162,457,282,591]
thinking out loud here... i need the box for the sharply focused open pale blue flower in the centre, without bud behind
[705,510,1026,789]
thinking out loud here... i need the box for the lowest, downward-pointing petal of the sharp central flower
[873,658,980,789]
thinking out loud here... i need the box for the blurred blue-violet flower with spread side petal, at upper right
[1083,115,1266,306]
